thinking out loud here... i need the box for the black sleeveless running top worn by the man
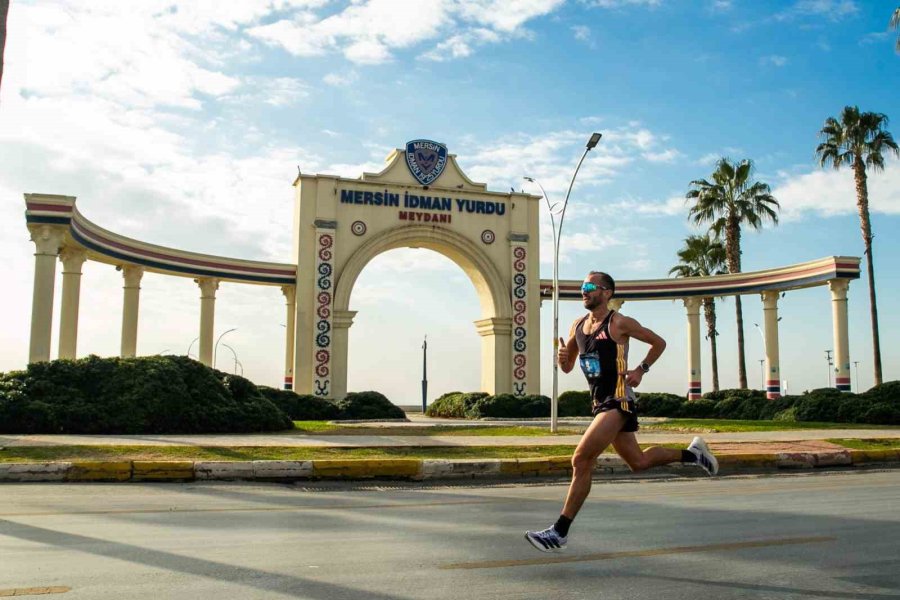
[575,310,631,402]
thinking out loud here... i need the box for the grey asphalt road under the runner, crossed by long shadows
[0,470,900,600]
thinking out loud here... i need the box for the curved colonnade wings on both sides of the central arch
[25,194,859,398]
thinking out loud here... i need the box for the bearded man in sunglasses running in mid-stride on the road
[525,271,719,552]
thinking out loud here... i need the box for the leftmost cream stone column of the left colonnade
[28,225,66,363]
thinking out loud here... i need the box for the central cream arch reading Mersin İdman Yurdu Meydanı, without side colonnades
[293,140,541,398]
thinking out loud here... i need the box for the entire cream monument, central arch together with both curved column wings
[25,140,859,398]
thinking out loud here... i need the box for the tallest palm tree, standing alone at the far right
[816,106,900,385]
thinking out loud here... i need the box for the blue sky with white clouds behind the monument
[0,0,900,404]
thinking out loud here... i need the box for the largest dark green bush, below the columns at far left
[0,356,292,434]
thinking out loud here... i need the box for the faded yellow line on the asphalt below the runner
[438,536,837,570]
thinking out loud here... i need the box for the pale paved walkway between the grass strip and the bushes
[0,429,900,447]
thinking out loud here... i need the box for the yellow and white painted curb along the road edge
[0,449,900,483]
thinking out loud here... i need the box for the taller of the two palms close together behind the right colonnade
[687,158,779,388]
